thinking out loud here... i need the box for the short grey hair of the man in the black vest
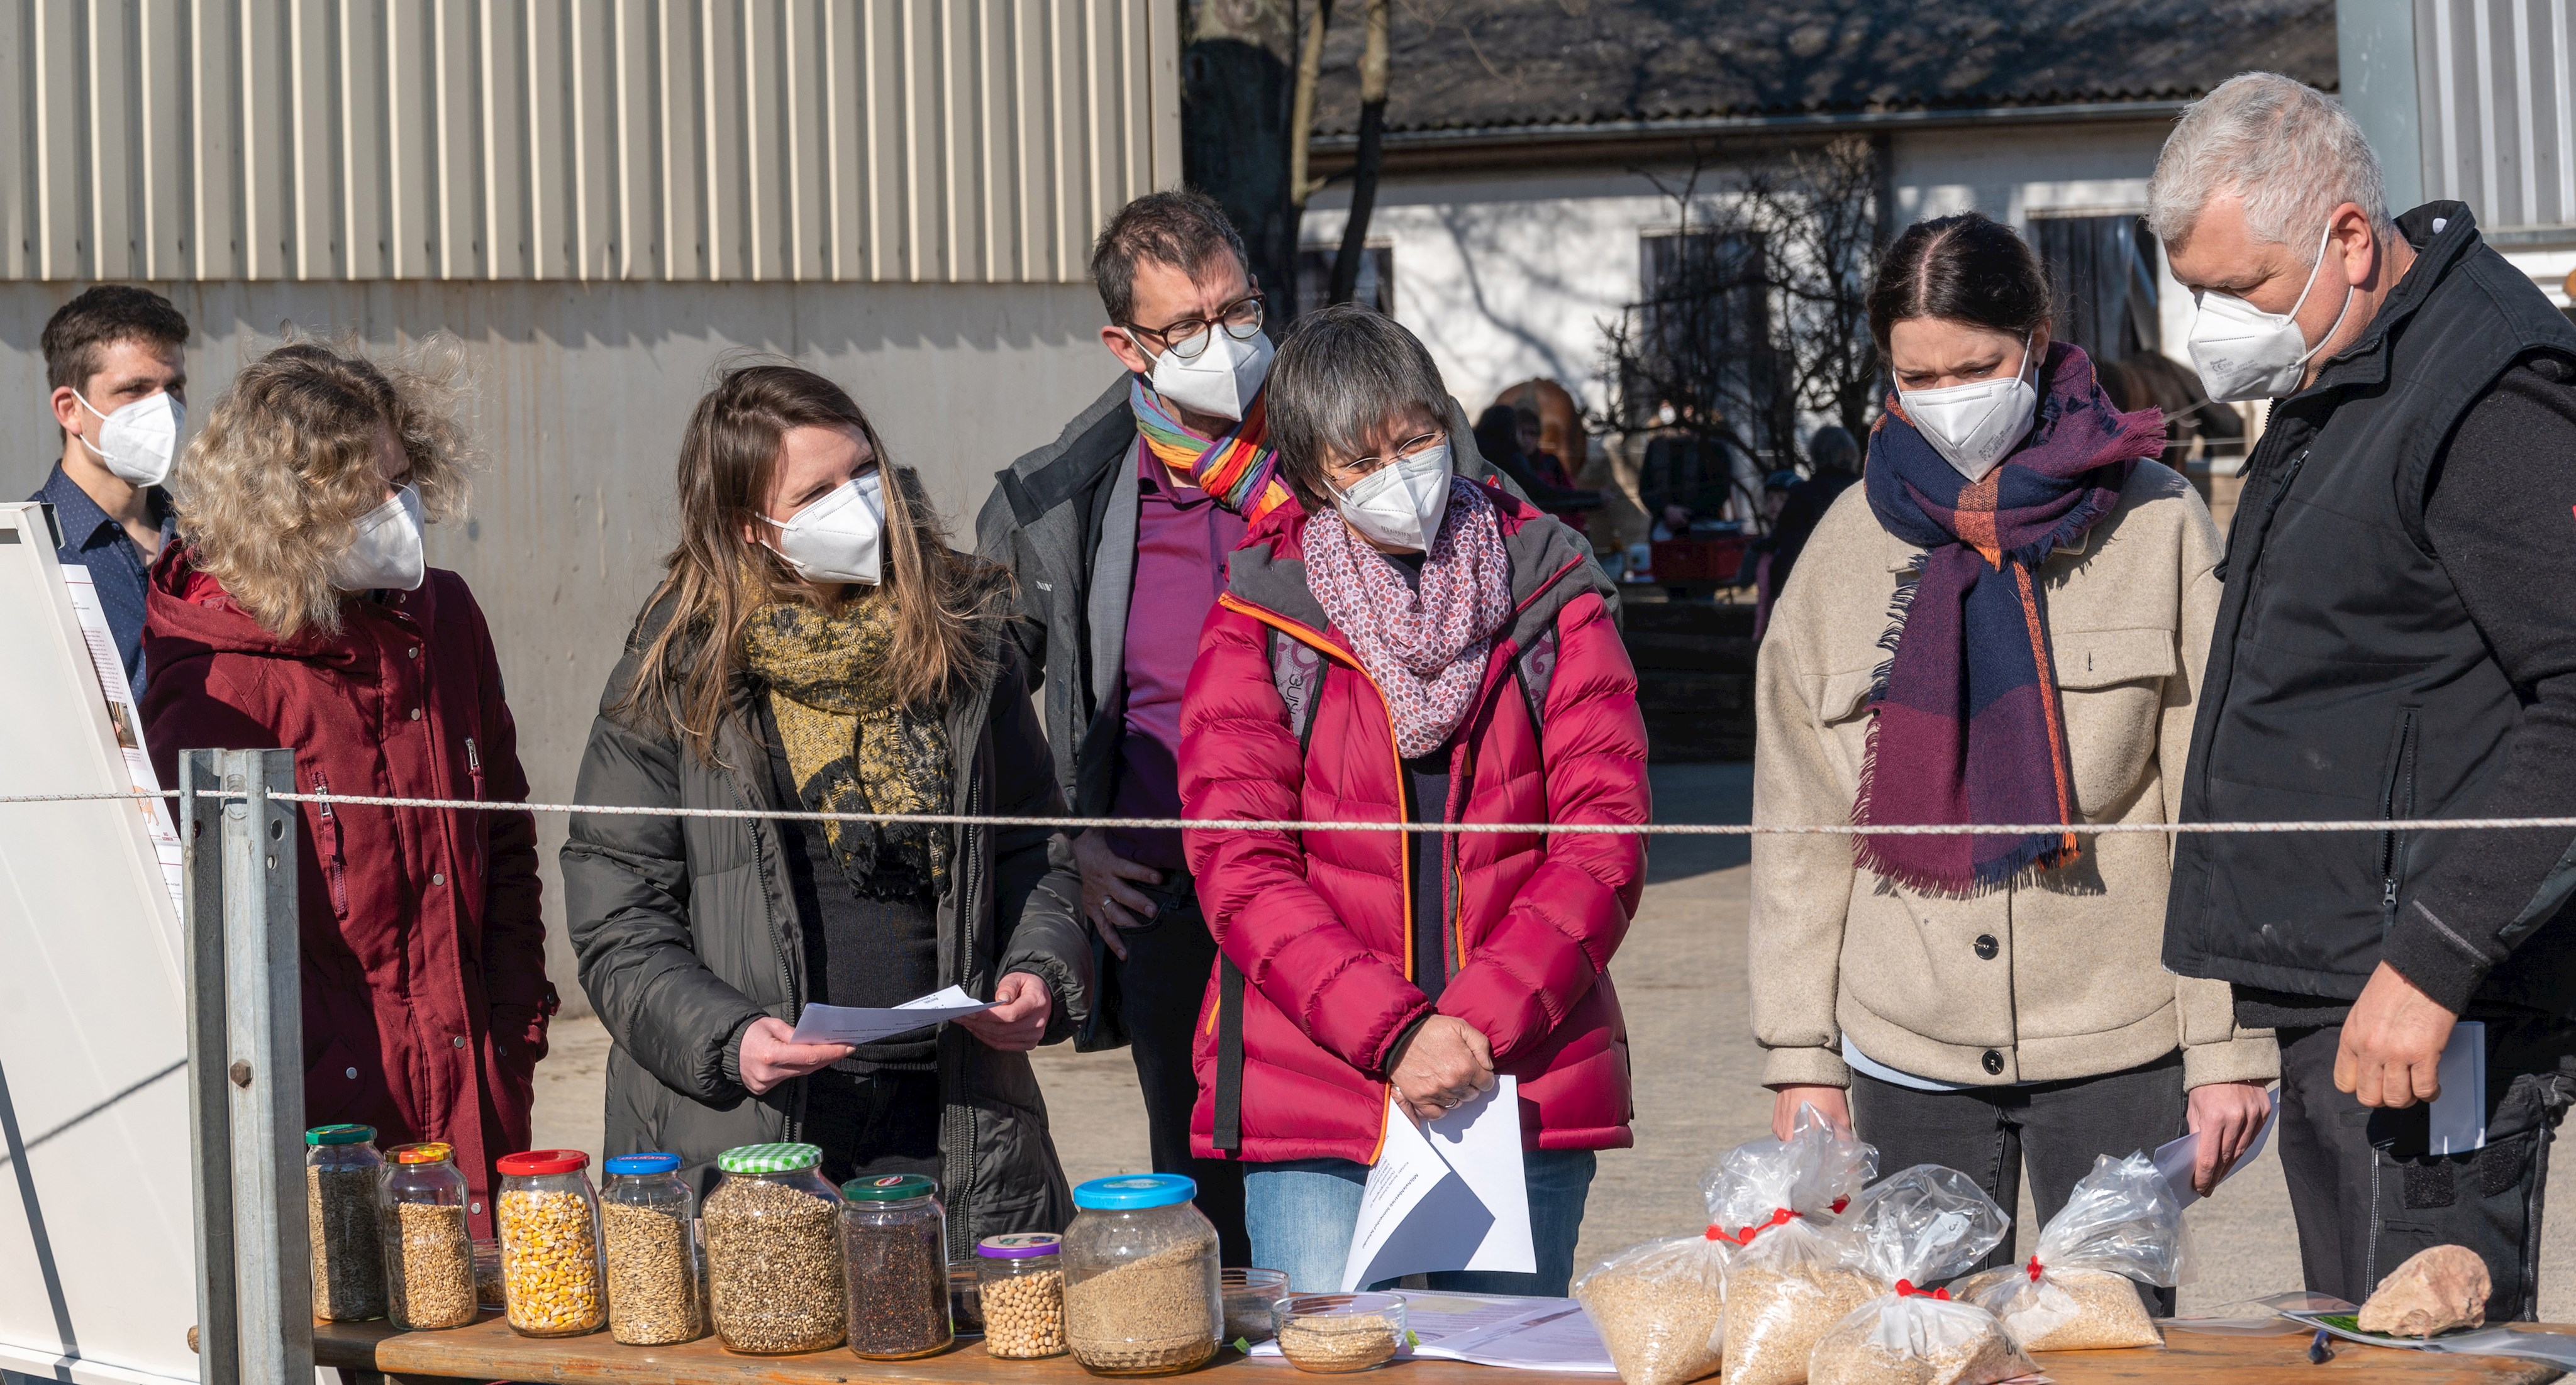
[2146,72,2388,265]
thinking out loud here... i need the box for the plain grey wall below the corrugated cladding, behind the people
[0,280,1118,1009]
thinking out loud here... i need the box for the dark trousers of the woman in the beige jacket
[1852,1053,2184,1315]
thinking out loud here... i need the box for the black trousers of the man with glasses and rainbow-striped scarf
[1110,870,1252,1264]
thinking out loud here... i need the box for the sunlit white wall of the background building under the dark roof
[1304,124,2190,424]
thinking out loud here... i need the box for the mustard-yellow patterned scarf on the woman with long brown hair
[742,592,953,898]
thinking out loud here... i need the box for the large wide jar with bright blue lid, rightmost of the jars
[1066,1174,1226,1375]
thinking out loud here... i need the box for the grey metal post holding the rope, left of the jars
[216,749,314,1382]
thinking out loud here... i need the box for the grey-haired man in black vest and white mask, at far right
[2148,72,2576,1318]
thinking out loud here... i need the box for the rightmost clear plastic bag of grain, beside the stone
[1950,1153,2184,1352]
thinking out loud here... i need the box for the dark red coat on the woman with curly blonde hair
[144,546,557,1236]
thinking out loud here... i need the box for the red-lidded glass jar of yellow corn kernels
[497,1148,608,1336]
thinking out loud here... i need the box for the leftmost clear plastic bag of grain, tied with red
[1574,1107,1878,1385]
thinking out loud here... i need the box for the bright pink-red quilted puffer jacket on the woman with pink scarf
[1180,489,1652,1161]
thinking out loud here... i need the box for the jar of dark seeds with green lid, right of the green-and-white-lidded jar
[840,1174,956,1362]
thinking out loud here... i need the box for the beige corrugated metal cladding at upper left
[0,0,1180,283]
